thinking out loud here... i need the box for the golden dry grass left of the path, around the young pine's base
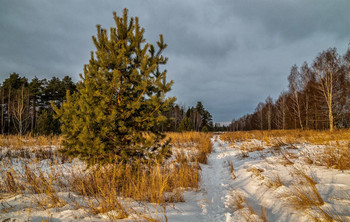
[0,132,212,221]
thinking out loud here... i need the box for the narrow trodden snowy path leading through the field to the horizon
[202,135,232,221]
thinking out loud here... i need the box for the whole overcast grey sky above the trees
[0,0,350,122]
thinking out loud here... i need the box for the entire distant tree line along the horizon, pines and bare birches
[4,45,350,135]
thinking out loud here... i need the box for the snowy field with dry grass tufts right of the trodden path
[221,130,350,221]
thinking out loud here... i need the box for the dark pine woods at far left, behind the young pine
[0,73,76,135]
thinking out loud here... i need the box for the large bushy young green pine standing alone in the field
[55,9,175,165]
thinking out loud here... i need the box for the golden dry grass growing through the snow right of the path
[221,130,350,221]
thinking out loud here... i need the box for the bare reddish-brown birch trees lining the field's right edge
[229,48,350,131]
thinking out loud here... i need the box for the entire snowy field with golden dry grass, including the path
[0,130,350,221]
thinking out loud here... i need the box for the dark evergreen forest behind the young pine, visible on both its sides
[0,73,219,135]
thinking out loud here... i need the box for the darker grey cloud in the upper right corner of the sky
[222,0,350,41]
